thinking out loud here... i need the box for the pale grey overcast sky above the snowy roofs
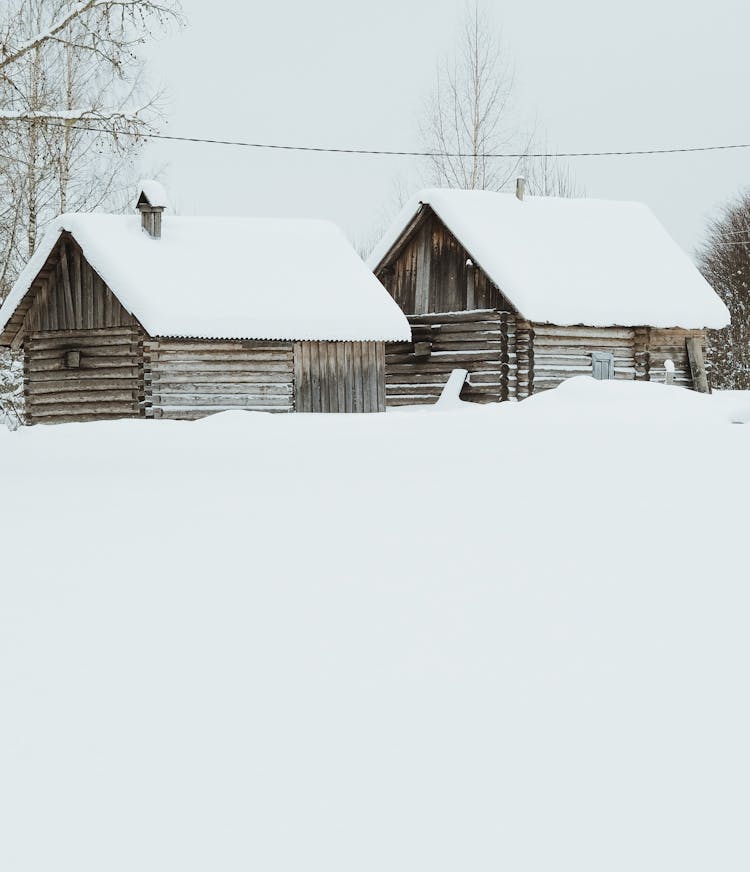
[146,0,750,252]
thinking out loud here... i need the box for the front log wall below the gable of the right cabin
[385,309,517,406]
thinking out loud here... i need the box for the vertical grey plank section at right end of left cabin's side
[294,342,385,412]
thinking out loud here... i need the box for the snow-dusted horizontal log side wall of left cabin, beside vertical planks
[144,339,294,420]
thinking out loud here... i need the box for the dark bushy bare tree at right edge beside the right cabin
[698,191,750,390]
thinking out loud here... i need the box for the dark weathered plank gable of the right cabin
[375,206,515,315]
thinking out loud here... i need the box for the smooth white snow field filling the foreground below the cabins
[0,378,750,872]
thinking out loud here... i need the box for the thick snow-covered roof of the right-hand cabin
[368,189,729,329]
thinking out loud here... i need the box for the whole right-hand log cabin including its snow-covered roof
[368,186,729,405]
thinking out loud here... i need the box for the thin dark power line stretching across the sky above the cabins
[47,122,750,160]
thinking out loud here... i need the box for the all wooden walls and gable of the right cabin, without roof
[376,207,705,405]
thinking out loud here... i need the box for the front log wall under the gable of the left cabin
[24,327,144,424]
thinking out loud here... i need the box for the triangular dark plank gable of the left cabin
[0,233,140,346]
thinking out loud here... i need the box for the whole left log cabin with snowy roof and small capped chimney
[0,182,410,424]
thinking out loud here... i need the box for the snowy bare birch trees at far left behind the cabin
[0,0,182,422]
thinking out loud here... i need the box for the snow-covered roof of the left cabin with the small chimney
[0,214,411,341]
